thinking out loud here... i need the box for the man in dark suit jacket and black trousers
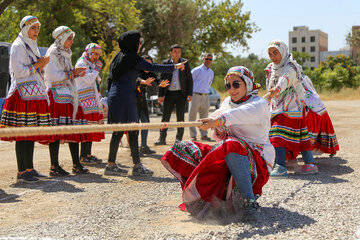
[155,44,193,145]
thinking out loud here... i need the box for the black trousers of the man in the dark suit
[160,90,187,141]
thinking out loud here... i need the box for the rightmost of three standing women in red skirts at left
[75,43,105,165]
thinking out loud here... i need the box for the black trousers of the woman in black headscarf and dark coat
[108,131,140,164]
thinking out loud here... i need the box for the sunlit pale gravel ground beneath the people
[0,101,360,239]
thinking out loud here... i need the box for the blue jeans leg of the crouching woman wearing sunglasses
[225,152,255,200]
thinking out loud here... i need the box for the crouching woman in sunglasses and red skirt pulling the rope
[161,66,275,221]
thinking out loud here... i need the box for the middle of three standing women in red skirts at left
[44,26,89,176]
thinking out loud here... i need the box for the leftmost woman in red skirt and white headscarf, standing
[0,16,52,183]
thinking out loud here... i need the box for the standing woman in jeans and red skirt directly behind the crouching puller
[268,40,318,177]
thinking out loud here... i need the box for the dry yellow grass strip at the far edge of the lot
[219,88,360,101]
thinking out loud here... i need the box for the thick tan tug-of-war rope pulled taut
[0,122,203,138]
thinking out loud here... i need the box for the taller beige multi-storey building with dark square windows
[289,26,328,69]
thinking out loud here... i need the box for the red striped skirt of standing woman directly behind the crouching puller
[269,113,311,159]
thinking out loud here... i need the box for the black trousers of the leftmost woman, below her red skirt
[15,141,35,172]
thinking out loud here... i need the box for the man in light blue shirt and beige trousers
[189,53,214,141]
